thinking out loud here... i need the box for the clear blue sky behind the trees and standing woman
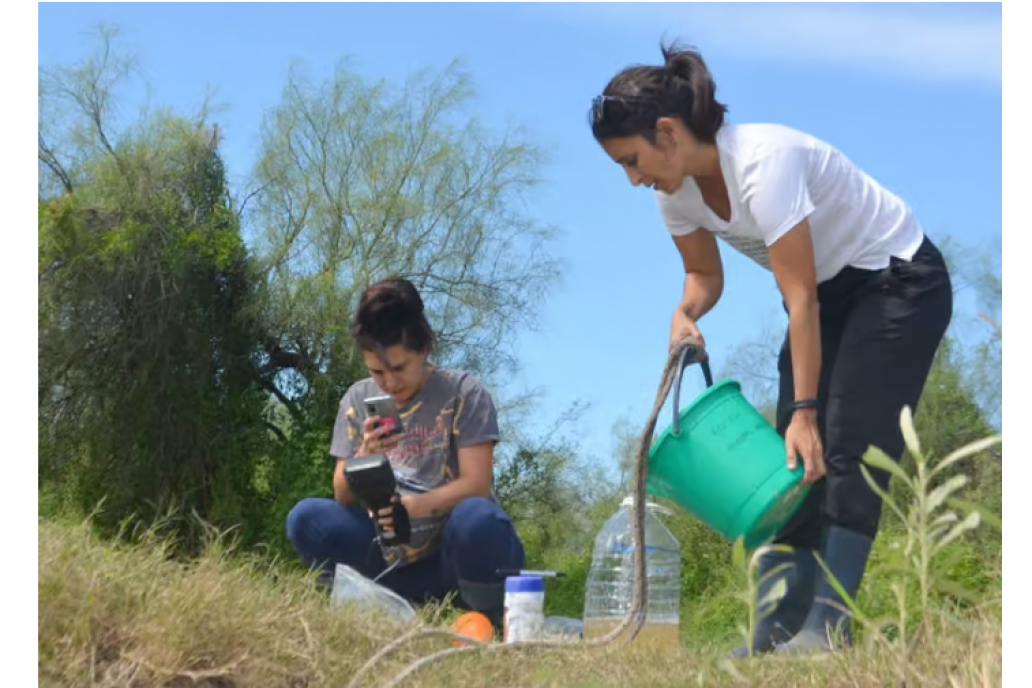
[38,3,1002,468]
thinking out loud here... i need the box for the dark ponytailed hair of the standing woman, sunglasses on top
[591,44,728,143]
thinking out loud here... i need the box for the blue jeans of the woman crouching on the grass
[287,497,525,621]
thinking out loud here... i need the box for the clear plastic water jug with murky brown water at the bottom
[584,497,681,649]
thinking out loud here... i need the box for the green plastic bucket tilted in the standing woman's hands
[646,348,809,550]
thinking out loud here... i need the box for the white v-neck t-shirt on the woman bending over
[656,124,925,283]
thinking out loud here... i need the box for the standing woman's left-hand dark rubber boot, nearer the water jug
[732,549,817,659]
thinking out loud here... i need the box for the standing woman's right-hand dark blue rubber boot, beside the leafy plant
[776,526,874,654]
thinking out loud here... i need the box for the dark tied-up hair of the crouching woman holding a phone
[351,277,436,353]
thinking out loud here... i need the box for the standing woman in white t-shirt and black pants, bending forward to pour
[591,40,953,656]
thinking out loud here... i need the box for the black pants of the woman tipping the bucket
[775,238,954,549]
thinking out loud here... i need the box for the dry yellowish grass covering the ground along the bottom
[38,515,1002,688]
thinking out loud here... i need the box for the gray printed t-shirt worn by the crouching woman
[329,368,498,565]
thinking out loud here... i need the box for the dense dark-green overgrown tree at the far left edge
[38,34,264,542]
